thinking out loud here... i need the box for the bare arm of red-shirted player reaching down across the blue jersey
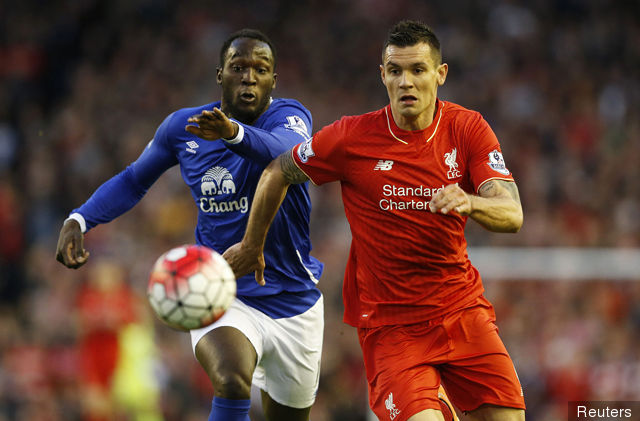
[223,151,308,285]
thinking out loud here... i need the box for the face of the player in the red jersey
[380,42,448,130]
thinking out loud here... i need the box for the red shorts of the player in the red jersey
[358,306,525,421]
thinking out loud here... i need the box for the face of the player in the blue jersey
[218,38,277,124]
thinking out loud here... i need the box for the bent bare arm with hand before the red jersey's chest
[429,180,523,232]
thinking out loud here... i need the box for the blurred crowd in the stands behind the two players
[0,0,640,421]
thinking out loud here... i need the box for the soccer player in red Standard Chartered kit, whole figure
[225,21,525,421]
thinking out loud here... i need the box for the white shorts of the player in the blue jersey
[191,296,324,408]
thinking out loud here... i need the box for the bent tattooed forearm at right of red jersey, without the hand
[469,180,523,232]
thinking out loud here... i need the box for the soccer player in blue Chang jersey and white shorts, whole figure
[56,29,324,421]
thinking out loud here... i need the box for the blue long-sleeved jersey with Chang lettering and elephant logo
[73,99,323,317]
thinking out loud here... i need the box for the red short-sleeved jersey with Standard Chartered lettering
[293,100,513,327]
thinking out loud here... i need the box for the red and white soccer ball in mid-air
[147,245,236,331]
